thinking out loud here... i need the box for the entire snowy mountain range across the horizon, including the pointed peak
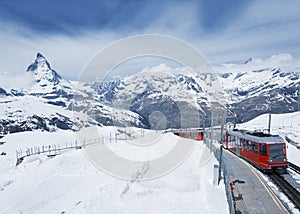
[0,53,300,132]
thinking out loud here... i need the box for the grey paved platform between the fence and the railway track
[223,150,288,214]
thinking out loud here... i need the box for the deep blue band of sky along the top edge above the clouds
[0,0,249,36]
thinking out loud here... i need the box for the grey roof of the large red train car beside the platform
[228,129,284,143]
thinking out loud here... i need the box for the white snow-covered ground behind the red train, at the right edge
[237,112,300,166]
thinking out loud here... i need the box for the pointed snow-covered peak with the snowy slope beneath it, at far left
[0,53,78,133]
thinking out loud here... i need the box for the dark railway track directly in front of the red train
[269,173,300,210]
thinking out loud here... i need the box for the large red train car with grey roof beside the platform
[225,130,288,172]
